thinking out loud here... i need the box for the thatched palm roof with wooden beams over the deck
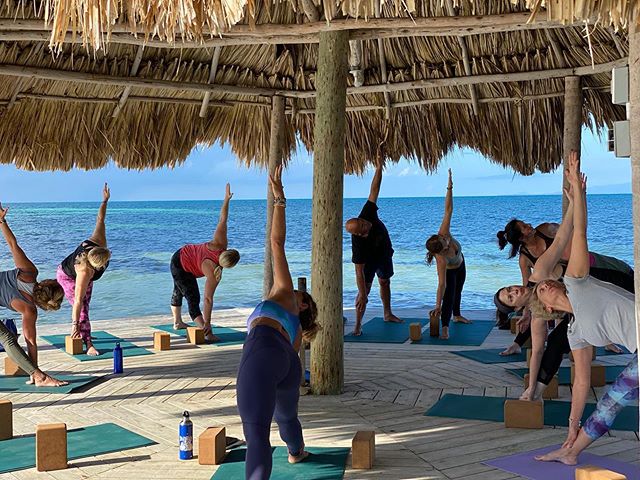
[0,0,637,174]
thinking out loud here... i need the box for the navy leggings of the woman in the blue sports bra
[236,325,304,480]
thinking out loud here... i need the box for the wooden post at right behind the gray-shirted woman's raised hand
[562,77,582,217]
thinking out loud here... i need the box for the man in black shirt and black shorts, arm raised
[345,166,402,335]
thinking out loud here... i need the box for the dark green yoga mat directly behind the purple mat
[425,393,638,432]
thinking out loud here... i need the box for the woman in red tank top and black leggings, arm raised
[171,183,240,342]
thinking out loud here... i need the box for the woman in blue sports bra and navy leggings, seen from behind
[236,166,319,480]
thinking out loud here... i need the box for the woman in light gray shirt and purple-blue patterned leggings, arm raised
[529,155,638,465]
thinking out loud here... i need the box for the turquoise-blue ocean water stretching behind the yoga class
[0,195,633,323]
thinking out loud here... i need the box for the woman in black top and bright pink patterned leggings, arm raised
[56,183,111,356]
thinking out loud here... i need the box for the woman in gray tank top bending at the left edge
[0,204,67,387]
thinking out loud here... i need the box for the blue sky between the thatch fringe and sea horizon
[0,126,631,203]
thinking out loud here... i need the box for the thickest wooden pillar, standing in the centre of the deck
[311,31,349,395]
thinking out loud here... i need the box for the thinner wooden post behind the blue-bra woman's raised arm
[262,97,284,298]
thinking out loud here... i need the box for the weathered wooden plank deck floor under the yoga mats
[0,309,640,480]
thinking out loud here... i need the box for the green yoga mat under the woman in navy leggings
[211,447,350,480]
